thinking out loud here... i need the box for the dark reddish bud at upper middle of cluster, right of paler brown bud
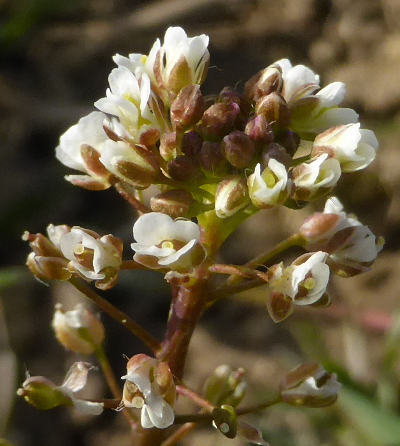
[199,102,240,141]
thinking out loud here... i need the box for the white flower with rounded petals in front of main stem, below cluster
[131,212,200,270]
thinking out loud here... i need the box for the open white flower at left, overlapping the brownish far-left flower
[60,226,123,289]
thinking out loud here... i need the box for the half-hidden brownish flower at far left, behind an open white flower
[22,224,71,280]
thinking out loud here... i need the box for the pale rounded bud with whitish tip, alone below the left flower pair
[52,305,104,355]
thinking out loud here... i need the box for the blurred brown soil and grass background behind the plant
[0,0,400,446]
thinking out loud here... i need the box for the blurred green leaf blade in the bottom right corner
[338,387,400,446]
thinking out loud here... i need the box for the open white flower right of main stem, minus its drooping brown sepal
[270,251,329,305]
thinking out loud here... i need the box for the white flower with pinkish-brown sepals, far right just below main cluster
[299,197,383,276]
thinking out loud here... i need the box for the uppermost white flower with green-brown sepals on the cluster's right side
[273,59,358,137]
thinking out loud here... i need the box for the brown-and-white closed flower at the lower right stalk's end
[280,363,341,407]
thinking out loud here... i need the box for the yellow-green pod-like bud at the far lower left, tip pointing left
[17,376,72,410]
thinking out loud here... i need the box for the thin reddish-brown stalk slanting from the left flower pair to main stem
[69,277,161,354]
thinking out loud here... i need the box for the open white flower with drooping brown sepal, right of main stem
[267,251,329,322]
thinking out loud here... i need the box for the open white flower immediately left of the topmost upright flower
[94,65,163,143]
